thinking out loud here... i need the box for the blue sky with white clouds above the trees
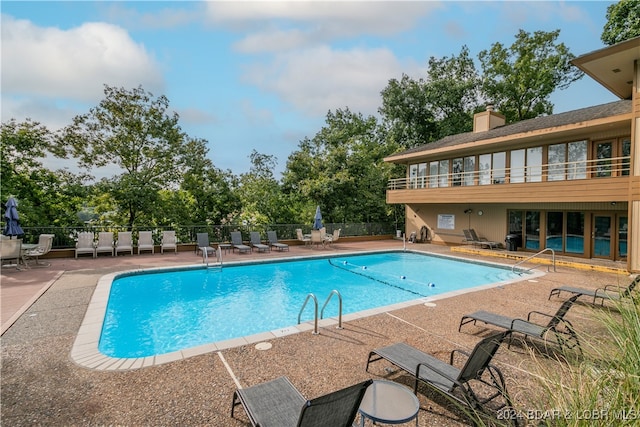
[0,0,617,177]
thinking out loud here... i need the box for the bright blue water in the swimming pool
[99,252,519,357]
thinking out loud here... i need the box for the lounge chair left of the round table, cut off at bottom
[231,377,372,427]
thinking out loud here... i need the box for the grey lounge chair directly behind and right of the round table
[366,331,513,420]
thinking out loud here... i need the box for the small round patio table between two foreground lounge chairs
[358,380,420,427]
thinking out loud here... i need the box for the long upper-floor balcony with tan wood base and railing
[387,156,630,203]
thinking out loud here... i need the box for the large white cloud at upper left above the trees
[2,15,163,106]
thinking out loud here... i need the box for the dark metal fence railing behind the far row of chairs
[13,222,396,249]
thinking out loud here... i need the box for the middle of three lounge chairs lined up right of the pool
[458,295,582,352]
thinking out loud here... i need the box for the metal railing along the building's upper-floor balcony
[387,156,631,190]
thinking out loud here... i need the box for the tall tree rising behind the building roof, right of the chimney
[478,30,583,123]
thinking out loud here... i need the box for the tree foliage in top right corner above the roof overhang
[600,0,640,46]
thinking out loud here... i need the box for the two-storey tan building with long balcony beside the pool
[385,37,640,272]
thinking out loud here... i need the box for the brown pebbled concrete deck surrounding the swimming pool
[0,240,630,426]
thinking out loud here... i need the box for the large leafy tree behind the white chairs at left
[59,85,186,227]
